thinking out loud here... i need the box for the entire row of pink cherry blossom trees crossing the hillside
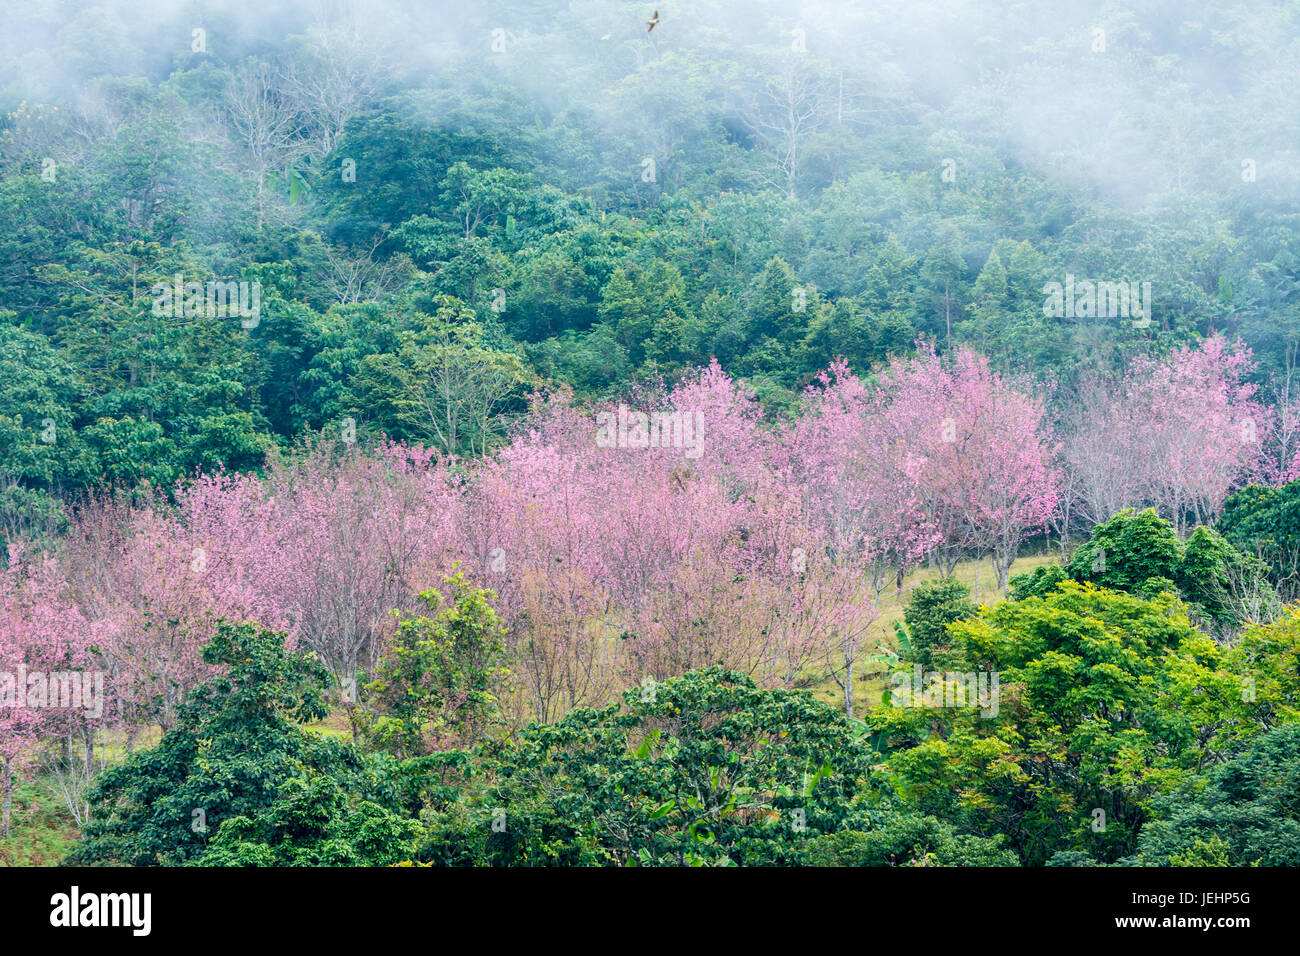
[0,338,1290,754]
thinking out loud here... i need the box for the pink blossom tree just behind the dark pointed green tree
[178,444,454,702]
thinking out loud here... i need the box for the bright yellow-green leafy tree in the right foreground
[871,583,1268,865]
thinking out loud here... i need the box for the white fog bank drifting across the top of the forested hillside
[0,0,1300,207]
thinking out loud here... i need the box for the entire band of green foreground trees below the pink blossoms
[58,598,1300,866]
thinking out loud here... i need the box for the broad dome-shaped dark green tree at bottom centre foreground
[420,669,884,866]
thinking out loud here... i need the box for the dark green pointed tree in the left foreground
[70,623,397,866]
